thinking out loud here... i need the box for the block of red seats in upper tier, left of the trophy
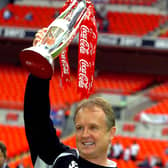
[0,4,57,28]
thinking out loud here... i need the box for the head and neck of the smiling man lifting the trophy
[74,98,115,166]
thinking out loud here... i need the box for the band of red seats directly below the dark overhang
[0,66,154,109]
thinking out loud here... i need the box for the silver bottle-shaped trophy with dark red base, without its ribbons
[20,0,87,79]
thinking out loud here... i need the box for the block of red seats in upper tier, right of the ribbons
[108,12,163,36]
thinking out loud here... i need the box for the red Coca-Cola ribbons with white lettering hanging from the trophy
[60,0,98,98]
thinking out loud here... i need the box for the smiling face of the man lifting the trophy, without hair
[75,106,115,160]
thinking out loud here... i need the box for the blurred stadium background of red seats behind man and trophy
[0,0,168,168]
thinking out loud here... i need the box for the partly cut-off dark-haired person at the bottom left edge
[0,142,9,168]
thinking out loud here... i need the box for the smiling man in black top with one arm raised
[24,71,116,168]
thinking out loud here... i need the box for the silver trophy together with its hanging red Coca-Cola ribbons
[20,0,98,97]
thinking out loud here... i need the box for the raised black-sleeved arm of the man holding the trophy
[24,75,63,164]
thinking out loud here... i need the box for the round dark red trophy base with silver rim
[20,47,54,79]
